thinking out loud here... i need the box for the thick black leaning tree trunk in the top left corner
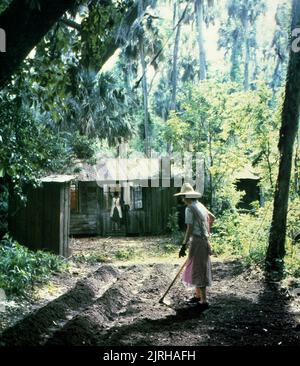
[0,0,76,89]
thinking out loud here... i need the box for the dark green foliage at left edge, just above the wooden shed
[0,95,70,199]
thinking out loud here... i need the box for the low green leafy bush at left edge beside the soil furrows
[0,235,67,296]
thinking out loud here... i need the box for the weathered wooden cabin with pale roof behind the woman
[70,159,178,236]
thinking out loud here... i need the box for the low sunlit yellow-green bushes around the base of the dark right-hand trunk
[211,197,300,277]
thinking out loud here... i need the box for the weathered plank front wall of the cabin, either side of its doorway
[70,182,177,236]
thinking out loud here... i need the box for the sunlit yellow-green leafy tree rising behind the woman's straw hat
[161,81,279,213]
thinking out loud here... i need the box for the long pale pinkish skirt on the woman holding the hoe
[182,235,212,287]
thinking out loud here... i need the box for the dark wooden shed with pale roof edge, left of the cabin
[8,175,74,257]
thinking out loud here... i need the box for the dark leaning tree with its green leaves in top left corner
[0,0,141,88]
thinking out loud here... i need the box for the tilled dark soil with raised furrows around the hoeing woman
[0,243,300,346]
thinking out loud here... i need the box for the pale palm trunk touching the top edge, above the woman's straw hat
[195,0,206,80]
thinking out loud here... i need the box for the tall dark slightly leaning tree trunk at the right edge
[266,0,300,270]
